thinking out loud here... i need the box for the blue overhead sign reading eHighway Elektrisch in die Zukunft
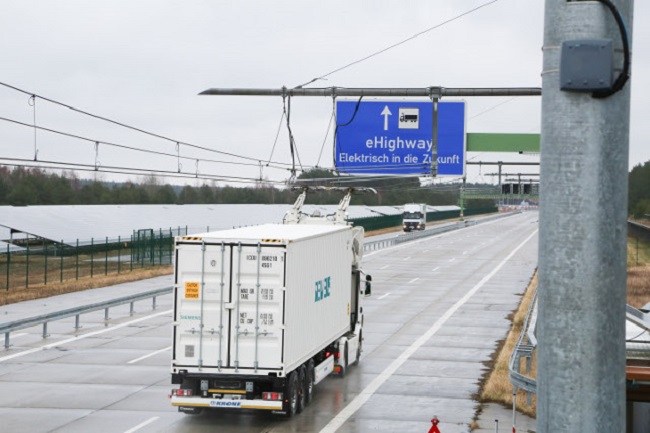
[334,101,465,176]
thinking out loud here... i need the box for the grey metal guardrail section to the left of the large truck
[0,287,172,348]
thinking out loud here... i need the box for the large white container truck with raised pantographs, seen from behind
[170,190,372,416]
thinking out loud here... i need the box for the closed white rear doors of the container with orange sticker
[173,241,285,371]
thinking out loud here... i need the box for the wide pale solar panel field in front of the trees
[0,204,458,246]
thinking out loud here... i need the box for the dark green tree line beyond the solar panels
[0,166,494,207]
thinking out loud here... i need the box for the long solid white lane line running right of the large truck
[320,230,538,433]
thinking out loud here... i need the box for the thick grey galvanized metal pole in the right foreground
[537,0,633,433]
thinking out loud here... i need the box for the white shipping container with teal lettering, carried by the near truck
[172,224,355,377]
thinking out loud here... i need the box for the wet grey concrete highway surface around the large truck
[0,212,538,433]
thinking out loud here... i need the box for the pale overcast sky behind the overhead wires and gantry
[0,0,650,185]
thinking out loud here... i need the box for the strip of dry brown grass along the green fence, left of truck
[0,266,172,305]
